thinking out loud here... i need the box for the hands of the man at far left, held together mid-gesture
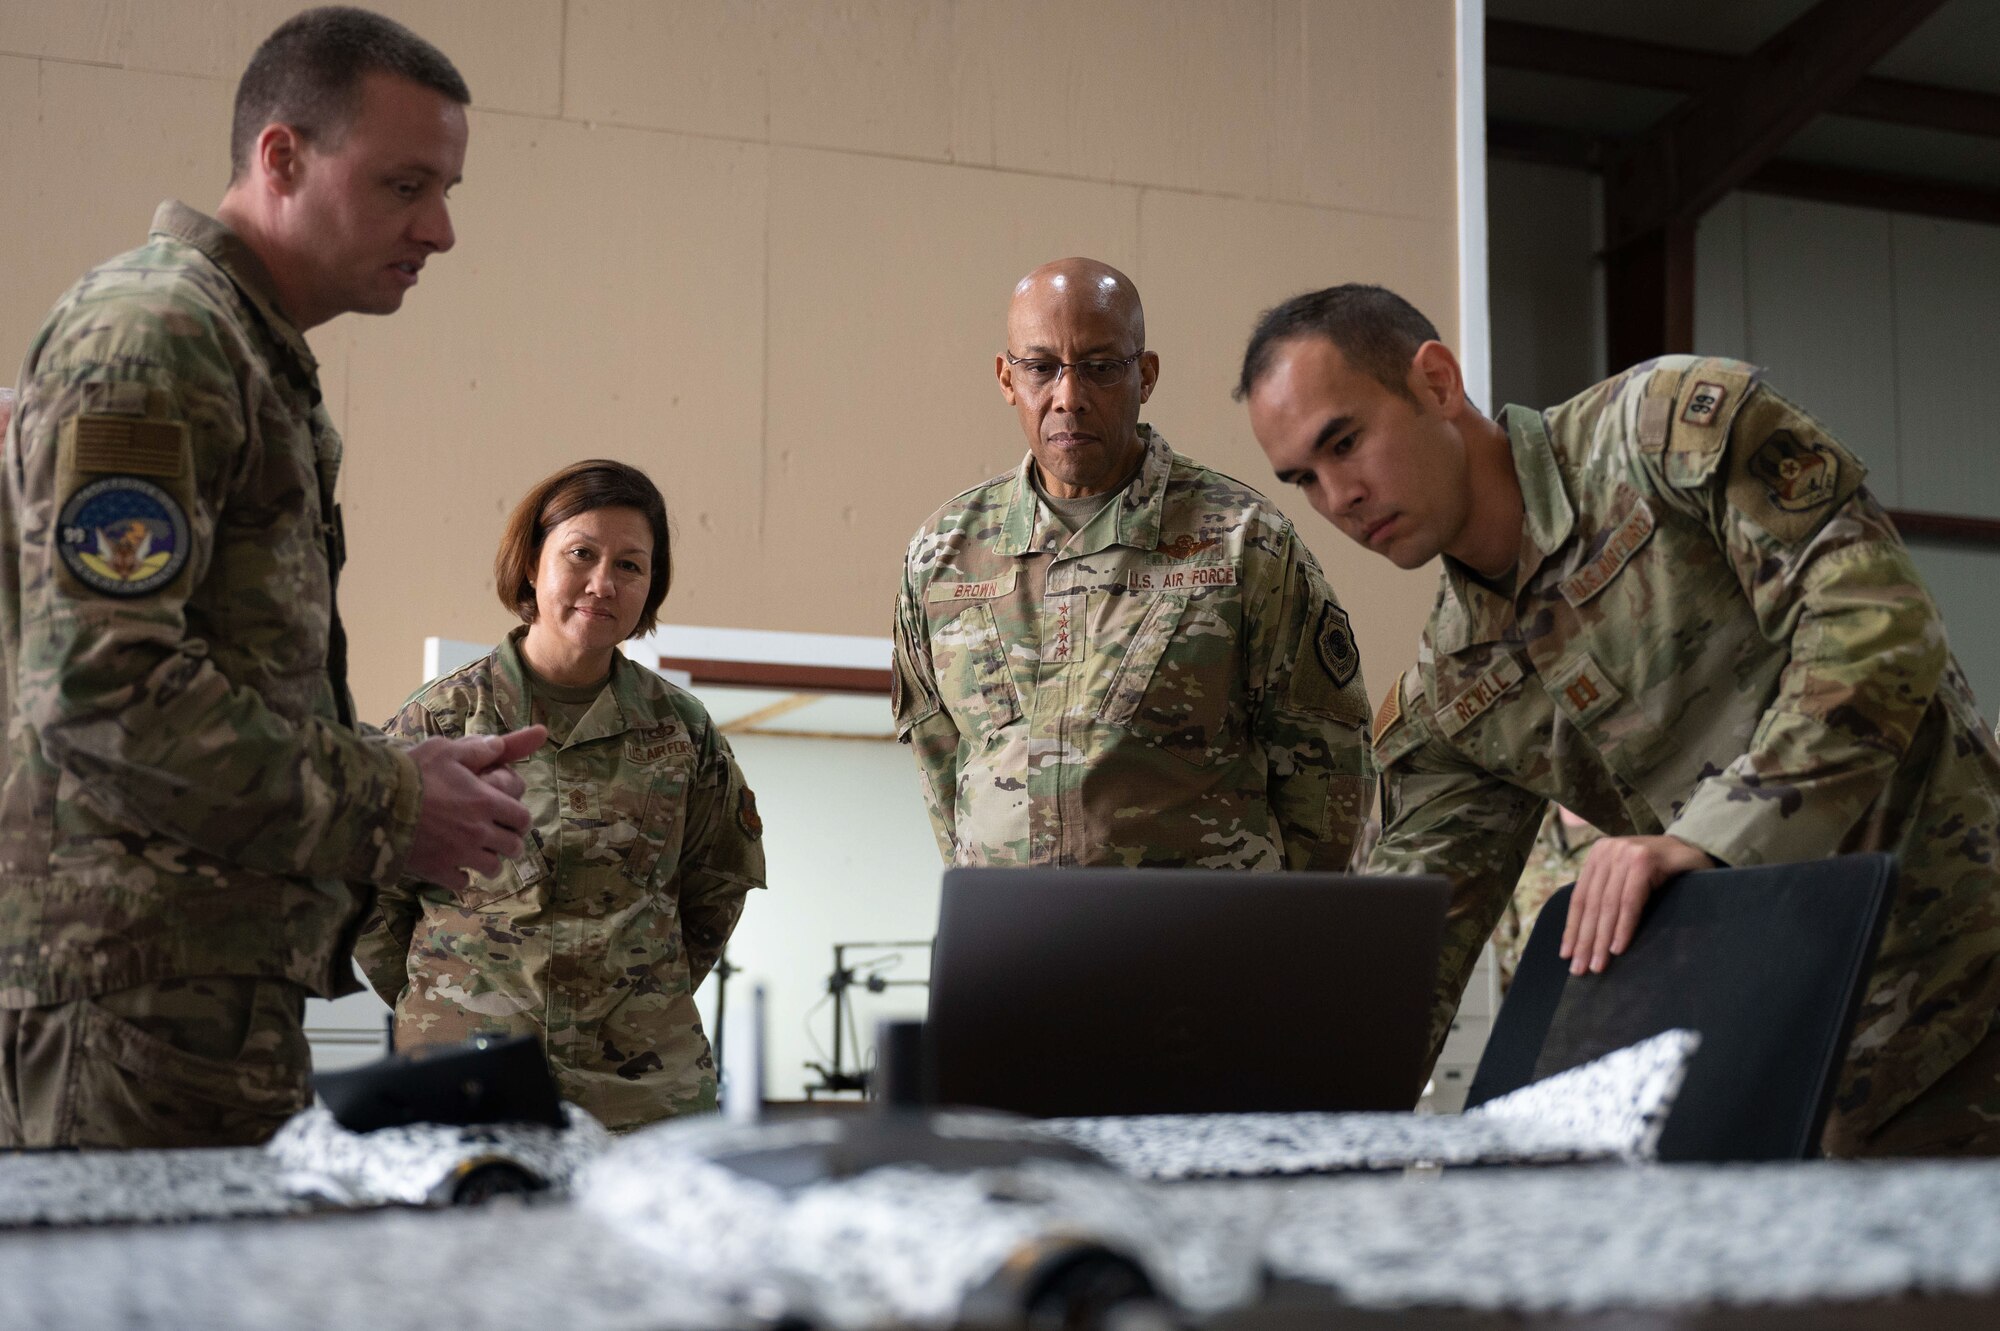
[404,725,548,891]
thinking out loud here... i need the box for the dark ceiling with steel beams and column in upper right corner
[1486,0,2000,364]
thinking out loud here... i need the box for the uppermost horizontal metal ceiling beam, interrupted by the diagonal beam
[1486,18,2000,138]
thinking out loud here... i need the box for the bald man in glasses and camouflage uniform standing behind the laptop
[894,260,1372,869]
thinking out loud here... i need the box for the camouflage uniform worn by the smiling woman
[356,630,764,1127]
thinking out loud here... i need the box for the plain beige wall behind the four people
[0,0,1456,715]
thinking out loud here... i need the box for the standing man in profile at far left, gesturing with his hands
[0,10,540,1147]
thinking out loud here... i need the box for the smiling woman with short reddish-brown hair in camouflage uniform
[356,460,764,1129]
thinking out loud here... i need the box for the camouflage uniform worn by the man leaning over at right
[1372,356,2000,1155]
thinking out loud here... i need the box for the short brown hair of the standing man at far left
[230,4,472,182]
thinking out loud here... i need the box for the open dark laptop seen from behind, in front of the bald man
[928,869,1450,1117]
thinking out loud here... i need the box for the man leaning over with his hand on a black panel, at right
[1240,288,2000,1155]
